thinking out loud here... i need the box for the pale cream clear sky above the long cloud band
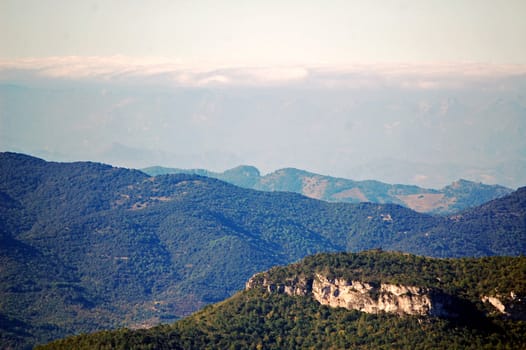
[0,0,526,65]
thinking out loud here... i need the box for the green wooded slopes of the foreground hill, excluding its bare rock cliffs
[39,251,526,349]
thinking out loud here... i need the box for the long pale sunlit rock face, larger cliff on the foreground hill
[246,274,455,317]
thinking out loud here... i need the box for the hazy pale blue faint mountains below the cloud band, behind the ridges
[0,77,526,188]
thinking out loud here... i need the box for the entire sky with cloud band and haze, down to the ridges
[0,0,526,187]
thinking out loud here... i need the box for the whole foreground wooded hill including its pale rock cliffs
[39,251,526,349]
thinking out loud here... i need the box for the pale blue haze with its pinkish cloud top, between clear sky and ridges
[0,56,526,187]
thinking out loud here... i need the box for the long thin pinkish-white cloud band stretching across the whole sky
[0,55,526,90]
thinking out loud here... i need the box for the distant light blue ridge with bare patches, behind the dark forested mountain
[142,166,512,214]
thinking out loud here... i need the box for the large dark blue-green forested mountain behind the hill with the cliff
[0,153,526,348]
